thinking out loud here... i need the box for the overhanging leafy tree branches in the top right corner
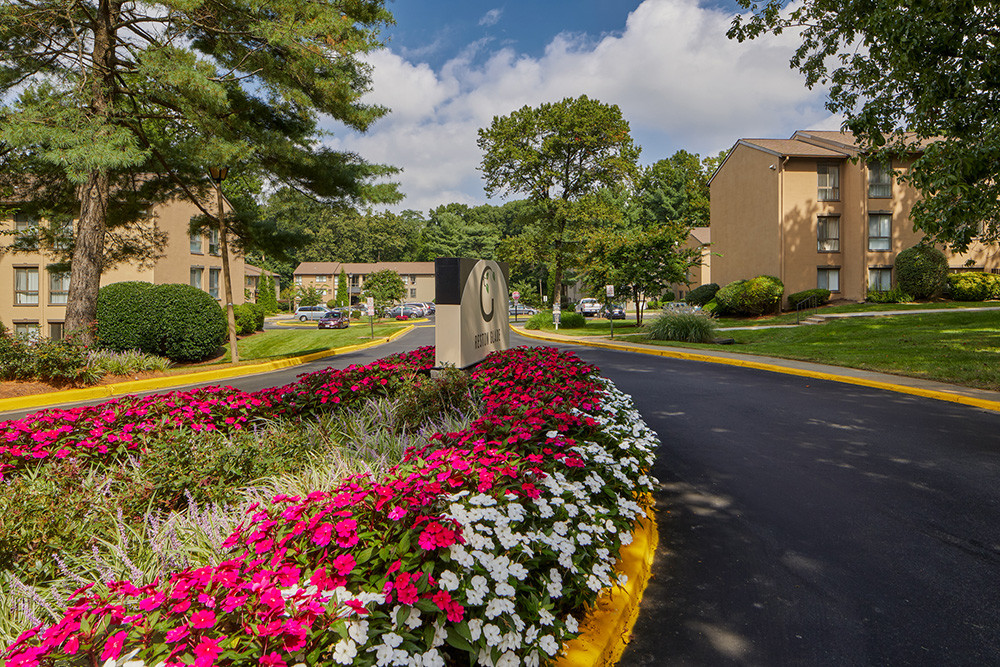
[729,0,1000,251]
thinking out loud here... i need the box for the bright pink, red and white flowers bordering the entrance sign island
[2,348,656,667]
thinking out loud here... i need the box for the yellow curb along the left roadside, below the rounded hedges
[0,324,415,412]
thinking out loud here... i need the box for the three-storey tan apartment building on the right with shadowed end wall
[709,130,1000,301]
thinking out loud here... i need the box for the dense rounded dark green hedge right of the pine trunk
[97,283,226,361]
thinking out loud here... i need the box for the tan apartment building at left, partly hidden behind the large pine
[0,196,245,339]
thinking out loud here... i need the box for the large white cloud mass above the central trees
[326,0,839,210]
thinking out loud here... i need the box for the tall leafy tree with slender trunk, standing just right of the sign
[477,95,640,302]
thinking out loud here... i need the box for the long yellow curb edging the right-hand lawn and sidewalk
[512,327,1000,412]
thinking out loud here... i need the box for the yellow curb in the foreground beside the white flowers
[555,505,660,667]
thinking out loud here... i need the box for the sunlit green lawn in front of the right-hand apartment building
[630,310,1000,390]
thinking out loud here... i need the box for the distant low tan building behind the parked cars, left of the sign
[292,262,435,303]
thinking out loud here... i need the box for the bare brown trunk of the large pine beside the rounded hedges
[64,171,110,345]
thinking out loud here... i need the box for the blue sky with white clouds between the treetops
[327,0,840,212]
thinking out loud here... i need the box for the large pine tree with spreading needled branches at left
[0,0,397,342]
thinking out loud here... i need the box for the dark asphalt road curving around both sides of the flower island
[4,328,1000,667]
